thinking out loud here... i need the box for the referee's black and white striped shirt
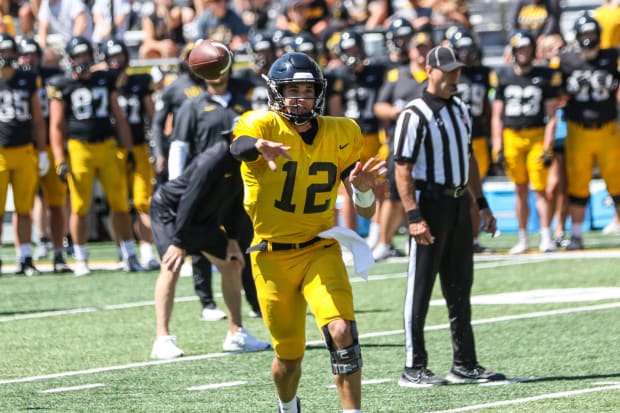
[394,91,472,187]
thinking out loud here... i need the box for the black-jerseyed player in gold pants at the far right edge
[560,13,620,250]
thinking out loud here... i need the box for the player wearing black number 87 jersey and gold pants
[47,36,144,276]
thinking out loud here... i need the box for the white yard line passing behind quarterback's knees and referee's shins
[0,301,620,385]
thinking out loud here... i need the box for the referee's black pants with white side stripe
[404,192,477,368]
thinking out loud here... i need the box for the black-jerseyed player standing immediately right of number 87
[102,39,159,270]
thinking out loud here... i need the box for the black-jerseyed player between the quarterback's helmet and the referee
[325,30,388,245]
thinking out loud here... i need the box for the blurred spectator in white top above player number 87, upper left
[37,0,93,49]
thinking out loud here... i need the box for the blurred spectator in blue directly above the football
[196,0,249,51]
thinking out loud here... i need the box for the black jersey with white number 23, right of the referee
[490,66,562,130]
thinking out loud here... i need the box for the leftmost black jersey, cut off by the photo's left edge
[0,70,40,147]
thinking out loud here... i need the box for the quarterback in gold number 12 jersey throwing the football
[231,53,385,413]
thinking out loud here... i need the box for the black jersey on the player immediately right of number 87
[117,73,153,145]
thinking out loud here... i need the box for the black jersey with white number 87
[47,71,116,142]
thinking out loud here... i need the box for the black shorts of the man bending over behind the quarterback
[151,192,228,259]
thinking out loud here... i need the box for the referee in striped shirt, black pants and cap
[394,46,505,387]
